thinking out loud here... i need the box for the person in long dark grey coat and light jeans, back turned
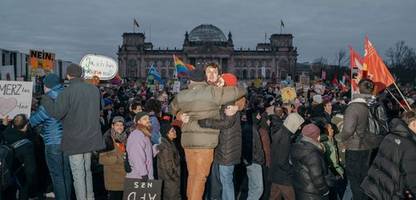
[41,64,105,200]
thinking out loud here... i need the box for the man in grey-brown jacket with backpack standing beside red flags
[336,79,380,199]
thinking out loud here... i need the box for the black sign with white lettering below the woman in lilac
[123,178,162,200]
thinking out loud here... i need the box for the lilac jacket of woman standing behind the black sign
[126,129,154,179]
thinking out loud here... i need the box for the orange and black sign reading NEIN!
[29,50,55,76]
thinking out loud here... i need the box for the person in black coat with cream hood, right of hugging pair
[269,113,305,200]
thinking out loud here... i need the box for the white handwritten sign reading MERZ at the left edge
[0,81,33,118]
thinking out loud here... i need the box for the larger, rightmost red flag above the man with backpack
[363,37,394,92]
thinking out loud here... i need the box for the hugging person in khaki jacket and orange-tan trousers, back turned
[170,65,246,200]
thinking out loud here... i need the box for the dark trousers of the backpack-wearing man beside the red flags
[345,150,371,200]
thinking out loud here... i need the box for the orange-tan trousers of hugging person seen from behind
[185,149,214,200]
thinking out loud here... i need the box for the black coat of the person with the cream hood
[270,126,293,185]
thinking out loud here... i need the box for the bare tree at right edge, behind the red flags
[386,40,416,68]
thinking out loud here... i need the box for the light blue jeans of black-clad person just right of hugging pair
[247,163,263,200]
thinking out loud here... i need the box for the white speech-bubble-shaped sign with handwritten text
[80,54,118,80]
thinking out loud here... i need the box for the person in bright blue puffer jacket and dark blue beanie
[29,73,72,199]
